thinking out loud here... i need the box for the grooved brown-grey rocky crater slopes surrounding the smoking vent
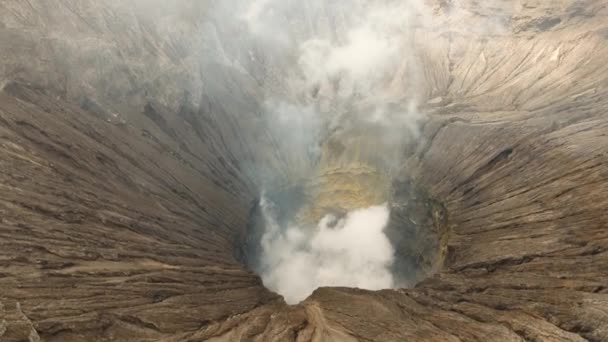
[0,0,608,342]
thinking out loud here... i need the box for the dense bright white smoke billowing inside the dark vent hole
[260,197,394,304]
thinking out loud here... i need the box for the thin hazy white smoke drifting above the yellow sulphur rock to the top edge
[233,0,429,188]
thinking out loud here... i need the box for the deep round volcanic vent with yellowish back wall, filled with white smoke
[236,159,447,303]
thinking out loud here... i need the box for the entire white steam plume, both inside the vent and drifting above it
[233,0,426,303]
